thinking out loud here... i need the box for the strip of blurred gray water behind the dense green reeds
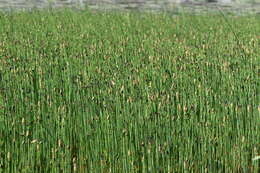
[0,0,260,14]
